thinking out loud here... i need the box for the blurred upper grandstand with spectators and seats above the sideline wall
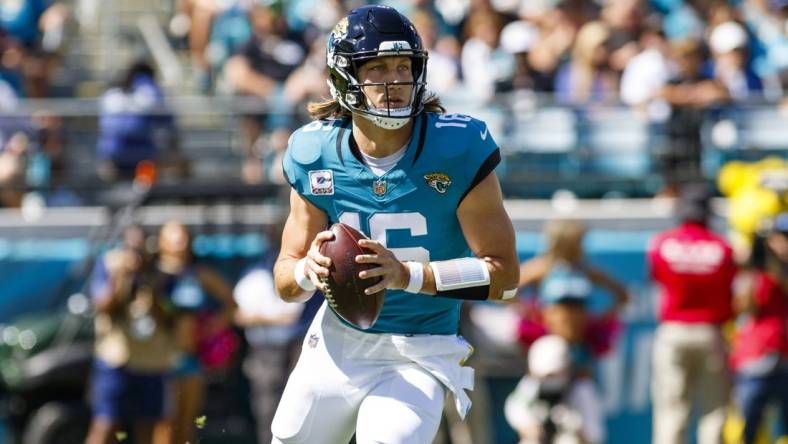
[0,0,788,207]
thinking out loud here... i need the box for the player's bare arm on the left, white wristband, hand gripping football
[274,190,333,302]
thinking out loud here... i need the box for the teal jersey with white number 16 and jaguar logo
[283,113,500,334]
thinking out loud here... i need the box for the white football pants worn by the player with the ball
[271,304,471,444]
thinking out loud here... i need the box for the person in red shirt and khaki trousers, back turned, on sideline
[648,184,736,444]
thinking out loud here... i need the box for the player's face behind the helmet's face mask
[358,56,413,109]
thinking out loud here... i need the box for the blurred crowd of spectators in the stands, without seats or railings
[0,0,788,207]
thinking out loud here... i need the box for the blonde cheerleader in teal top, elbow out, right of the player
[519,220,628,375]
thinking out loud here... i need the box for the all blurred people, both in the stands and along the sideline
[0,0,788,444]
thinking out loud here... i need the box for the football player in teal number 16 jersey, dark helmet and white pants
[272,6,519,444]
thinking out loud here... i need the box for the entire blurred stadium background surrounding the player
[0,0,788,444]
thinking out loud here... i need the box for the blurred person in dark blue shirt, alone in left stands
[97,62,181,181]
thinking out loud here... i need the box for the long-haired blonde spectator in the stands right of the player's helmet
[555,21,618,104]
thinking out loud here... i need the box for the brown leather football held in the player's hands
[320,223,386,330]
